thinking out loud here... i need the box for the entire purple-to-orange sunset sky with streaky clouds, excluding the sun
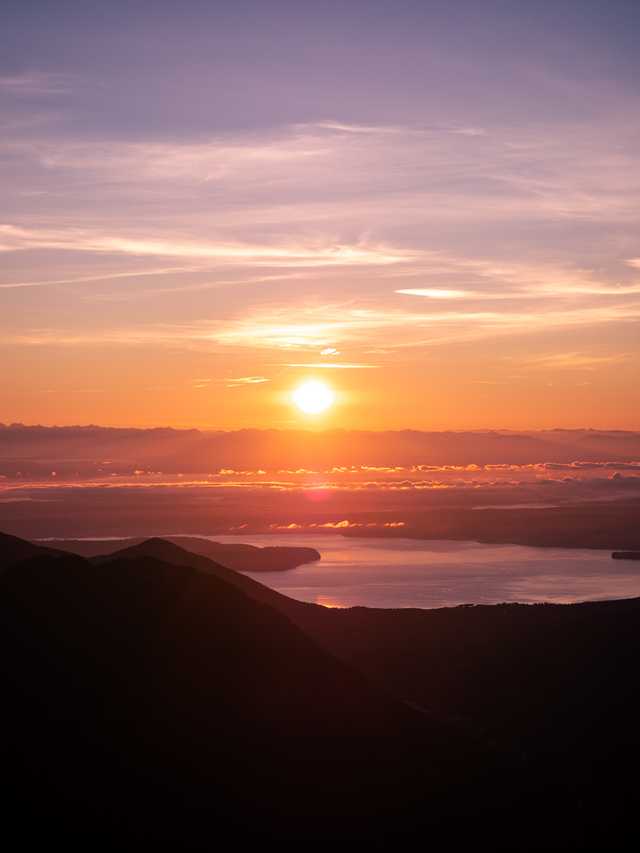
[0,0,640,430]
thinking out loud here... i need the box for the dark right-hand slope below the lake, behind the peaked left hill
[94,540,640,843]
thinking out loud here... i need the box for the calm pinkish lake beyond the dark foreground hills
[209,534,640,607]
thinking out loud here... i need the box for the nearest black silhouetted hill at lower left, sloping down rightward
[0,536,524,849]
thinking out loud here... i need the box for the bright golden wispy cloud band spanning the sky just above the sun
[6,302,640,350]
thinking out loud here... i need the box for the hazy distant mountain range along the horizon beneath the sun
[0,424,640,477]
